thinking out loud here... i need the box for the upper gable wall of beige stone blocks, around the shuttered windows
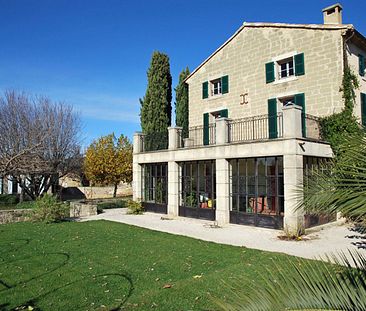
[187,26,344,126]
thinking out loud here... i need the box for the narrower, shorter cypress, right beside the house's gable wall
[175,67,189,137]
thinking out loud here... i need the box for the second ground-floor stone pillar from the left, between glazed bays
[168,161,180,217]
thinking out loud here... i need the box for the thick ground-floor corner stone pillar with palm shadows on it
[283,154,304,235]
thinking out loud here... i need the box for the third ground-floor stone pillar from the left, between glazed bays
[216,159,230,225]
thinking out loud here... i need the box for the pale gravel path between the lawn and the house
[80,209,366,259]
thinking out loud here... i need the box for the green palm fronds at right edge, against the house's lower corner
[298,135,366,220]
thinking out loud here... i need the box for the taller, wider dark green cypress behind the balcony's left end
[140,51,172,137]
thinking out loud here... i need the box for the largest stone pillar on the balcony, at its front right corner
[282,105,302,138]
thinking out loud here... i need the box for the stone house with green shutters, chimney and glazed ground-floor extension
[133,4,366,232]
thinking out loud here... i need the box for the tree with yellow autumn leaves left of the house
[84,134,132,197]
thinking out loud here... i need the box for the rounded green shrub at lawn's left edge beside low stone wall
[30,194,70,223]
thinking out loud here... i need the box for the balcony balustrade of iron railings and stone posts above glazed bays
[134,105,322,153]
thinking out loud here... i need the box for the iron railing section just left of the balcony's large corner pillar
[228,112,283,142]
